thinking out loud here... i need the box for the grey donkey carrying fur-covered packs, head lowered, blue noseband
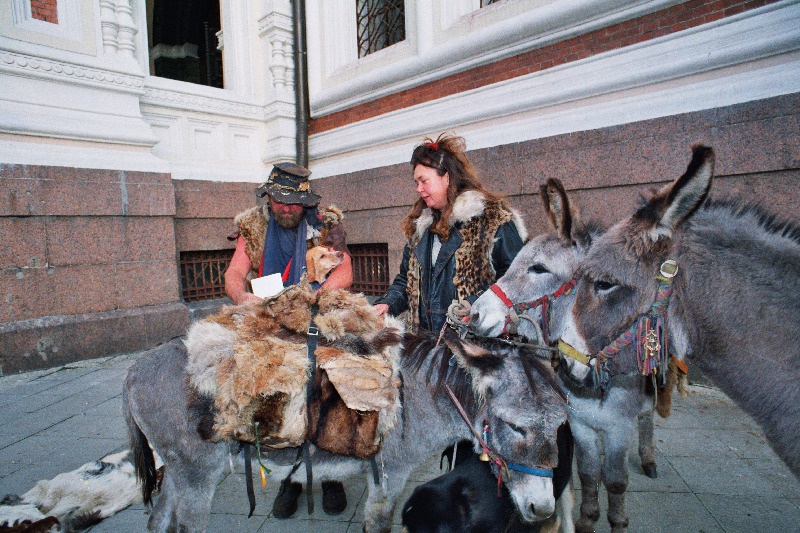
[123,333,571,532]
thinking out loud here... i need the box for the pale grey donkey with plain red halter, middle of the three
[470,179,656,531]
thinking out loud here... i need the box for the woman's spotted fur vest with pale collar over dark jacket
[406,191,527,331]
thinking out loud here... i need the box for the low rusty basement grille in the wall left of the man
[181,250,233,302]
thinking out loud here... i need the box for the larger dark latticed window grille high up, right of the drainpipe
[356,0,406,57]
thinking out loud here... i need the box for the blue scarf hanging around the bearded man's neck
[261,207,321,287]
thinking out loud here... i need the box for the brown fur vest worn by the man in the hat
[229,204,347,276]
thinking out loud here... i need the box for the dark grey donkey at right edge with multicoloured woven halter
[562,146,800,531]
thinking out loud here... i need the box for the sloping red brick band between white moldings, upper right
[309,0,777,135]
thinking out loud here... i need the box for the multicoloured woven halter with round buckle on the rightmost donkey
[558,235,679,390]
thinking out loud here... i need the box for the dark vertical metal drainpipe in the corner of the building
[292,0,311,167]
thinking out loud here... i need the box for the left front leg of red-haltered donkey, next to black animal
[570,420,601,533]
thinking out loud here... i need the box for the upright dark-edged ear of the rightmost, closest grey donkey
[635,144,715,242]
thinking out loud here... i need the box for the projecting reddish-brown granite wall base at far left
[0,164,188,374]
